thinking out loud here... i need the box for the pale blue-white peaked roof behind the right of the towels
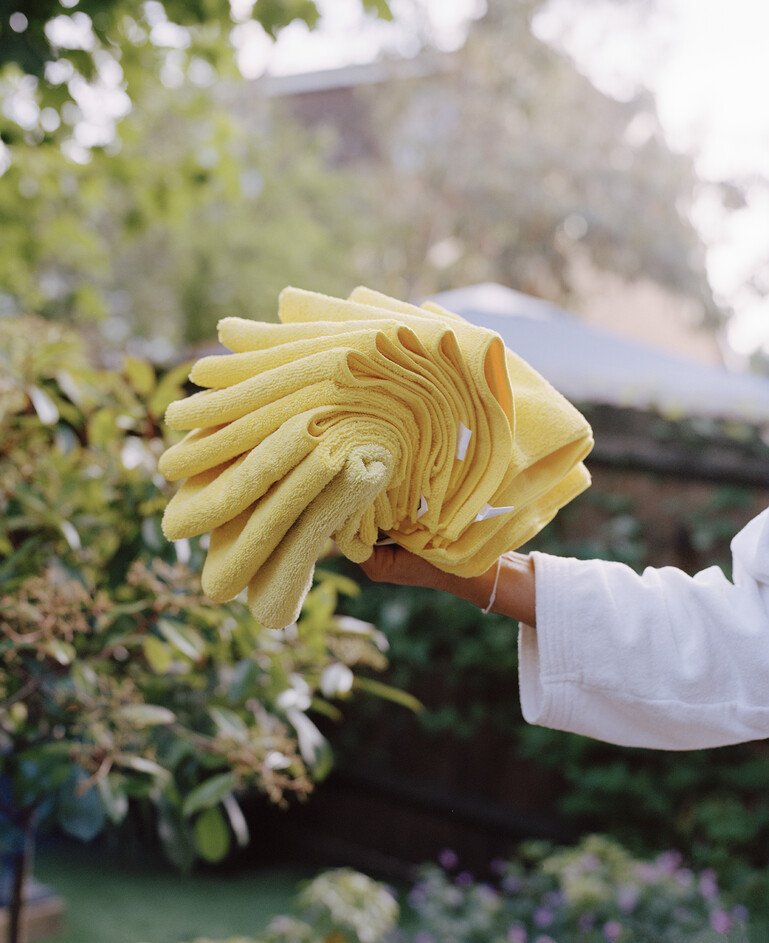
[433,283,769,425]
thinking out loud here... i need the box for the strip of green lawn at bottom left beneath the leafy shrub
[35,845,309,943]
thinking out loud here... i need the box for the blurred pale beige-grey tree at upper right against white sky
[363,0,722,323]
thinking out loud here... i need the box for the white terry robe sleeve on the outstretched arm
[518,509,769,750]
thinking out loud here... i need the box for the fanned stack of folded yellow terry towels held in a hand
[160,288,593,627]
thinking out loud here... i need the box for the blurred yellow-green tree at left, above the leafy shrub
[0,74,362,340]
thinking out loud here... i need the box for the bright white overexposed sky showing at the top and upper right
[233,0,769,355]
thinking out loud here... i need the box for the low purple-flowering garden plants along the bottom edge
[183,835,748,943]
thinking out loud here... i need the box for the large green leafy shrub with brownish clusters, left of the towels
[0,318,386,867]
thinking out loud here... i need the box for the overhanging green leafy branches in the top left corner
[0,0,391,144]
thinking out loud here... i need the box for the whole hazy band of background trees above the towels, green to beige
[0,0,723,350]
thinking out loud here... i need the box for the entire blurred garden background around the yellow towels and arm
[0,0,769,943]
